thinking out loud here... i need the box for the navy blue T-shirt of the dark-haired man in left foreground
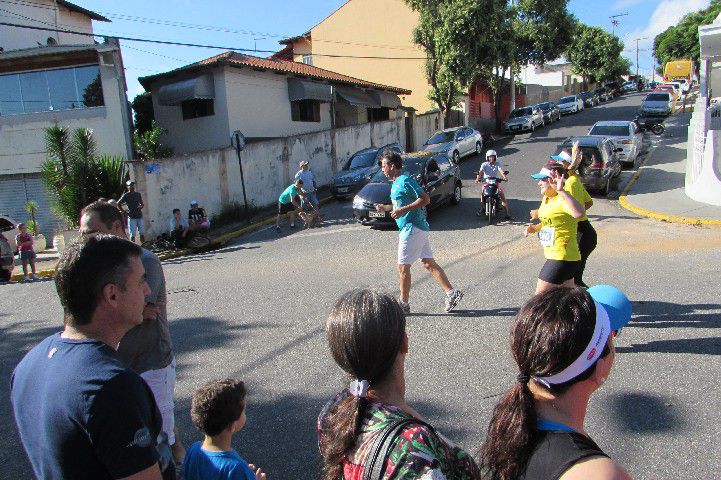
[10,333,162,480]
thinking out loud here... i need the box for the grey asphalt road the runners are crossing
[0,95,721,479]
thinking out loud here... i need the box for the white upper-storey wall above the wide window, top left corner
[0,0,93,51]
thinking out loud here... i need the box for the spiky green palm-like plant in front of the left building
[40,125,128,226]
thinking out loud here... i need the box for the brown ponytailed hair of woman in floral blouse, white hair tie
[320,290,406,480]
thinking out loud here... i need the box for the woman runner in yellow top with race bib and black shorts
[525,167,586,294]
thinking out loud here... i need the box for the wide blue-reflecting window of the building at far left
[0,65,105,115]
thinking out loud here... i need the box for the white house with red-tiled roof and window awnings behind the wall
[139,52,411,154]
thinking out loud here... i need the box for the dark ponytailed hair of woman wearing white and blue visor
[480,287,610,480]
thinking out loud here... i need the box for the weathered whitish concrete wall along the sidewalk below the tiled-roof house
[130,115,408,235]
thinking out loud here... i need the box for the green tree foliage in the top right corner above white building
[653,0,721,74]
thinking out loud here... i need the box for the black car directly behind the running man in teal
[353,152,463,225]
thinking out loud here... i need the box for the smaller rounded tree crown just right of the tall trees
[566,23,631,82]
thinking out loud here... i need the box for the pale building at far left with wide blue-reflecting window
[0,0,132,236]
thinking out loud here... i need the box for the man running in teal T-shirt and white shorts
[376,150,463,313]
